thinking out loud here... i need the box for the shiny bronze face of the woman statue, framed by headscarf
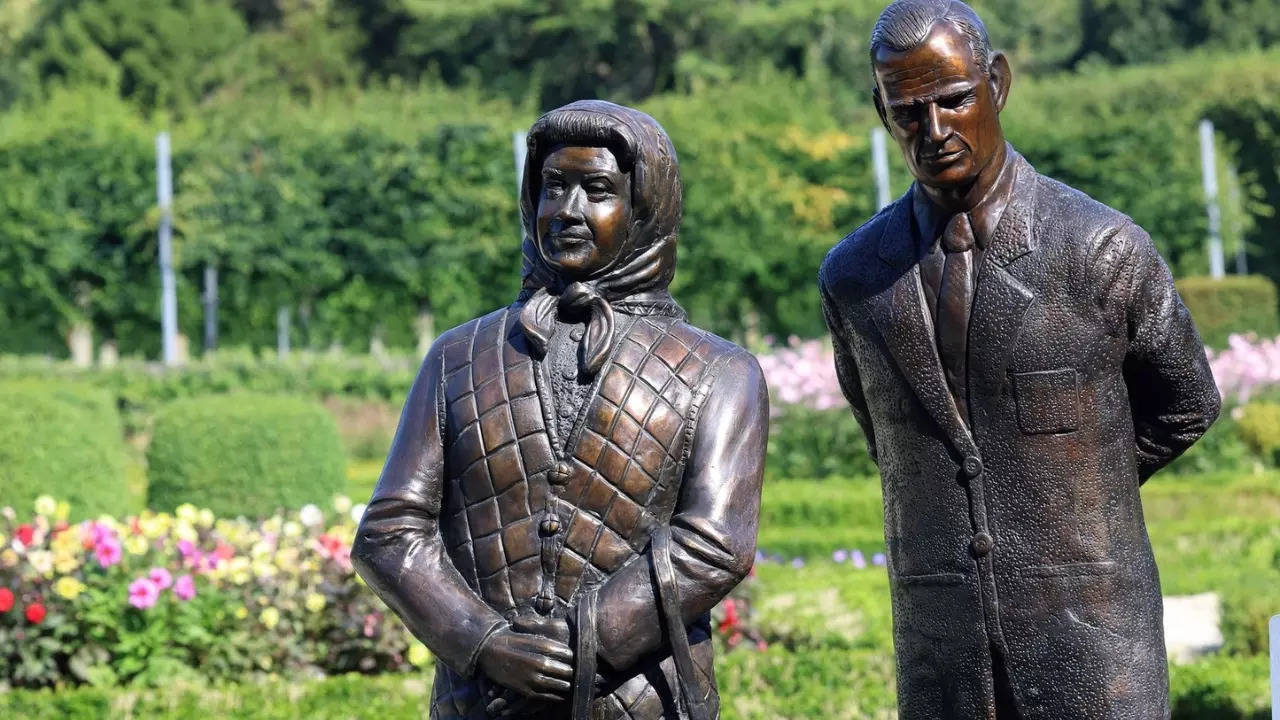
[538,146,631,278]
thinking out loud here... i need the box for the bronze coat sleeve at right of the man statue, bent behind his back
[1102,222,1222,482]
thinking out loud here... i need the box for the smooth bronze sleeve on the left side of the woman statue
[351,340,506,676]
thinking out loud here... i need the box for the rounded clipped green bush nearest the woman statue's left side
[147,395,346,516]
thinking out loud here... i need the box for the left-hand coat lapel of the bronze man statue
[869,186,974,455]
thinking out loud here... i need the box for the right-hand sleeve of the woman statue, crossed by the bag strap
[595,352,769,670]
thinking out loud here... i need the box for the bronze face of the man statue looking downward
[873,22,1009,188]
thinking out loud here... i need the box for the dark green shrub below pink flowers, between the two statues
[764,405,878,479]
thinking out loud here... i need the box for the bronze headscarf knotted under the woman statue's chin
[520,100,684,375]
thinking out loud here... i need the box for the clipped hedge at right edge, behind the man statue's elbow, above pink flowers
[1178,275,1280,347]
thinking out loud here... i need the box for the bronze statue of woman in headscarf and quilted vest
[352,101,768,720]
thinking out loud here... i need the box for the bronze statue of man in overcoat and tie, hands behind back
[819,0,1221,720]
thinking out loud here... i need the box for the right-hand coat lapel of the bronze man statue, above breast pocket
[968,155,1036,413]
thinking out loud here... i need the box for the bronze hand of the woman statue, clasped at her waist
[479,628,573,702]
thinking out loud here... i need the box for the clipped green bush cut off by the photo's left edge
[0,382,129,518]
